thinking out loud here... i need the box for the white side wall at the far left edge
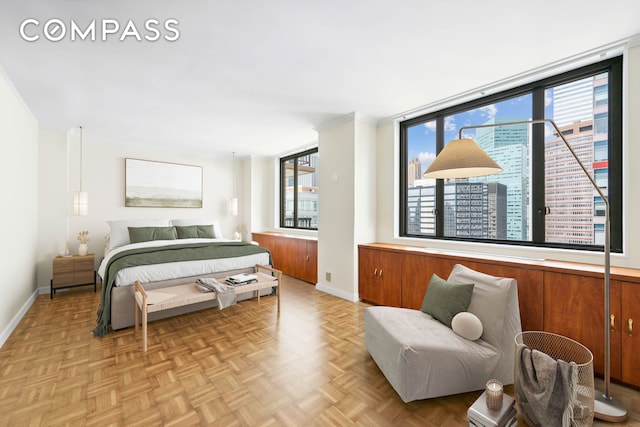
[0,68,38,346]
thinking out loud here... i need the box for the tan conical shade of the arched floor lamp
[423,138,502,179]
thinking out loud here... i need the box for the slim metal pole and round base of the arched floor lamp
[458,119,627,422]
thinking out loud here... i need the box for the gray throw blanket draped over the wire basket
[514,344,578,427]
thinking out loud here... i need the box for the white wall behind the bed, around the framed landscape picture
[37,128,244,288]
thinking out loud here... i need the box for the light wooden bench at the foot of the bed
[134,265,282,352]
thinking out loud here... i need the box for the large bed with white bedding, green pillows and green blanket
[93,219,271,336]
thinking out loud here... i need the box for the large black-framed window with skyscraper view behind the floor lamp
[400,57,622,252]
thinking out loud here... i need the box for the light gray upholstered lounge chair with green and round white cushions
[364,265,521,402]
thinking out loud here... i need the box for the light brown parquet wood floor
[0,277,640,426]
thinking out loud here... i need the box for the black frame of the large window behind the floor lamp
[398,55,623,253]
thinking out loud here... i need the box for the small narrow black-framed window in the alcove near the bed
[280,148,318,230]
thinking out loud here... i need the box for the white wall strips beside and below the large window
[376,46,640,268]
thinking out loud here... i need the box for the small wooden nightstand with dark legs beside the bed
[50,254,96,299]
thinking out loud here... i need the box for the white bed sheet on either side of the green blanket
[98,239,269,286]
